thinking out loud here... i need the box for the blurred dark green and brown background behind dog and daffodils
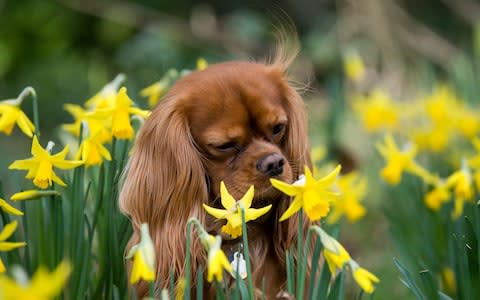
[0,0,480,299]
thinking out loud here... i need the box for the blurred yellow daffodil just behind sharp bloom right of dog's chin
[327,172,367,224]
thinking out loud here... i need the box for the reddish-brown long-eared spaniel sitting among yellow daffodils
[119,40,311,299]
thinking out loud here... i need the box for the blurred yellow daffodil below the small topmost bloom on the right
[353,90,400,132]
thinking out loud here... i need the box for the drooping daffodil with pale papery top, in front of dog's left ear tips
[126,223,156,284]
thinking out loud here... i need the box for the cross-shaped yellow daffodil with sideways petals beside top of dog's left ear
[95,87,150,139]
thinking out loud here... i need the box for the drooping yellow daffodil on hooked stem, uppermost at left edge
[0,88,35,137]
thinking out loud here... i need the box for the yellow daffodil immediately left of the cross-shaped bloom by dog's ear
[62,104,112,143]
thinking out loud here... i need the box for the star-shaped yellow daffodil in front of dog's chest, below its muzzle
[203,181,272,238]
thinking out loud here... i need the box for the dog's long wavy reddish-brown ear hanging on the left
[119,96,208,294]
